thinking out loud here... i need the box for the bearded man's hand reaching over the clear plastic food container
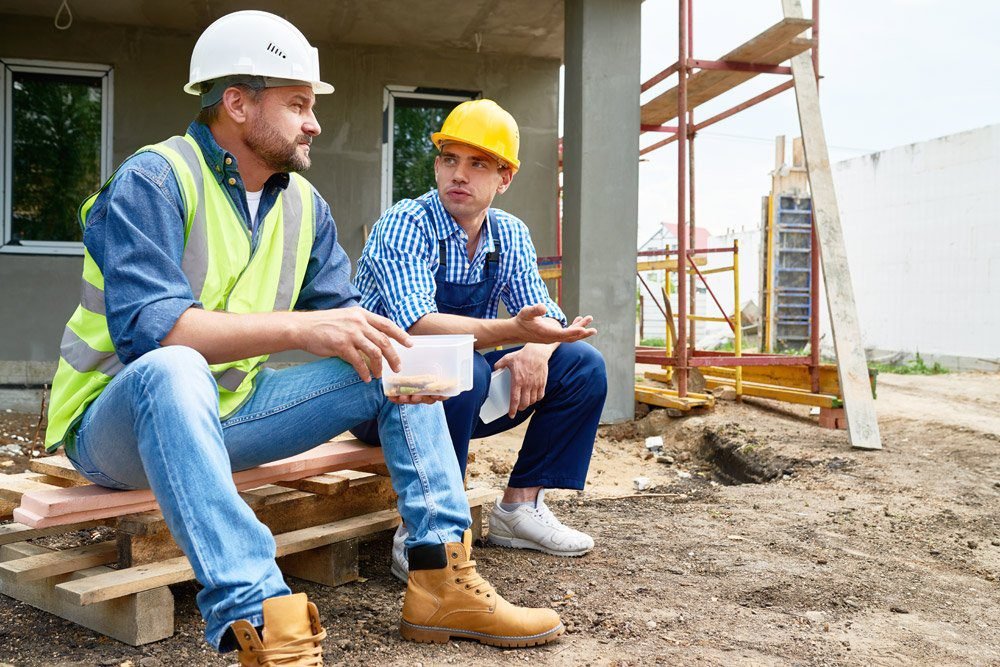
[296,306,410,380]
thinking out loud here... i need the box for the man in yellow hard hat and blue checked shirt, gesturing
[353,100,607,579]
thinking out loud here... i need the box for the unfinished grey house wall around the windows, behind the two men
[0,16,559,376]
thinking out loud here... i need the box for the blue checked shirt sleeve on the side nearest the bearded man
[355,200,438,330]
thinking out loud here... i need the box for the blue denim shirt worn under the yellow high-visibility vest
[83,122,358,364]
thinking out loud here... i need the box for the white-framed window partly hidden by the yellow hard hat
[382,86,479,211]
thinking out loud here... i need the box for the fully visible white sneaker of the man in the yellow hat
[489,489,594,556]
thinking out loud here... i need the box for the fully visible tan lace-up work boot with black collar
[399,531,565,647]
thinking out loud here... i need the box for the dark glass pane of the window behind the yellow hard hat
[392,97,462,204]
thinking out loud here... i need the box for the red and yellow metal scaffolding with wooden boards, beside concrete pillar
[636,0,881,449]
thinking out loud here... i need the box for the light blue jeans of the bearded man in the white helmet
[66,347,472,648]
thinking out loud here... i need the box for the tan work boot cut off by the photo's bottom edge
[230,593,326,667]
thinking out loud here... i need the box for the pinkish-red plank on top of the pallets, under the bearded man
[14,441,383,528]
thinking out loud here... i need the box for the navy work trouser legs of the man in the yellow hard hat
[351,342,608,490]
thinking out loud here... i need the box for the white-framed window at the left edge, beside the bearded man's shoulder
[0,60,112,255]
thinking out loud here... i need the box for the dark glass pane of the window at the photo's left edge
[11,72,101,242]
